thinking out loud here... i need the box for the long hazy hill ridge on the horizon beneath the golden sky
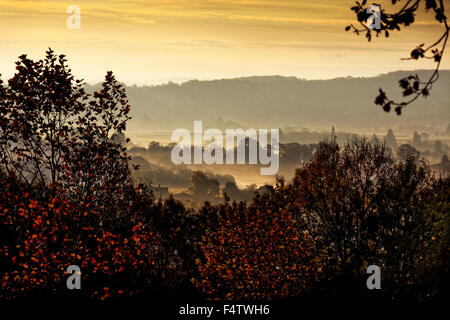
[88,70,450,131]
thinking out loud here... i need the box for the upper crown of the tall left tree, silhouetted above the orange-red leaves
[0,49,130,200]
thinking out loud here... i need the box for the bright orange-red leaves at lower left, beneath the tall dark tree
[0,178,159,300]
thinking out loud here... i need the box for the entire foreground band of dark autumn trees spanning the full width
[0,50,450,301]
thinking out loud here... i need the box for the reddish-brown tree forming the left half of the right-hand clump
[288,140,393,290]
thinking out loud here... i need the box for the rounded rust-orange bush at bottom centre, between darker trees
[194,201,323,300]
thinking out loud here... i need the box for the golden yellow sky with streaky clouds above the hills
[0,0,450,85]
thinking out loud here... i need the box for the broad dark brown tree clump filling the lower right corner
[285,140,449,299]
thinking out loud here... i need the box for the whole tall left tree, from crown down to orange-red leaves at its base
[0,50,160,299]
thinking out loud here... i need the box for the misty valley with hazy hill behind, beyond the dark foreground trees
[105,70,450,208]
